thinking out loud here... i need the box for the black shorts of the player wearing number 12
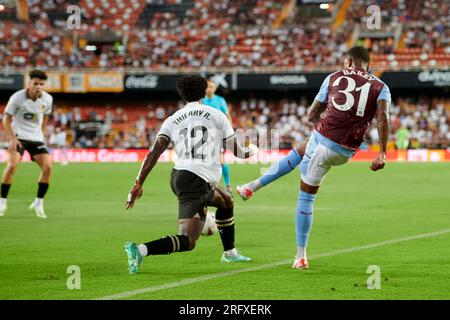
[170,169,214,221]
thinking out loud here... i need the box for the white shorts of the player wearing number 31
[300,134,350,187]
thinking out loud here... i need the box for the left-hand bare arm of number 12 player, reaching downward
[125,135,170,209]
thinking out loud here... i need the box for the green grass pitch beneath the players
[0,163,450,300]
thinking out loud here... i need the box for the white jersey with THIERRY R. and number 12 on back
[158,102,235,188]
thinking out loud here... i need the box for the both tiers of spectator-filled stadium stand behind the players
[0,0,450,152]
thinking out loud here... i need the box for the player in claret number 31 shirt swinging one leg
[237,47,391,269]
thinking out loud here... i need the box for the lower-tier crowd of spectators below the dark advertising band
[0,97,444,149]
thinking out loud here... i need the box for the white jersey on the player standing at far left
[5,89,53,142]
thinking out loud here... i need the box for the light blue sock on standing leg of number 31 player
[295,191,316,258]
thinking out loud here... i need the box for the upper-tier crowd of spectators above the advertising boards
[0,0,450,70]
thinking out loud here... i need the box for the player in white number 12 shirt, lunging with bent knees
[125,76,257,274]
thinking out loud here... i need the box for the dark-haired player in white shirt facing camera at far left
[0,70,53,219]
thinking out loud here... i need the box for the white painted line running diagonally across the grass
[94,229,450,300]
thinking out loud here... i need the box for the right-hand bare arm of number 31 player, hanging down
[370,99,389,171]
